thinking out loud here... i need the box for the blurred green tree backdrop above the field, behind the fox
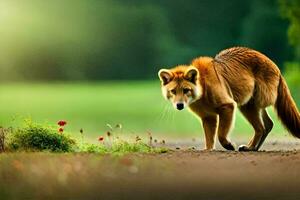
[0,0,300,80]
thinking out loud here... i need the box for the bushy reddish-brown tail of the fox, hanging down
[275,76,300,138]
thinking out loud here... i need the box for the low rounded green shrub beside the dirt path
[6,121,76,152]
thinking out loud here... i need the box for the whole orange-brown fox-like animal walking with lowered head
[158,47,300,151]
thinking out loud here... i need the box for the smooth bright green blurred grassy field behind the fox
[0,81,286,139]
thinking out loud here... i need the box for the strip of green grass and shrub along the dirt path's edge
[0,120,170,155]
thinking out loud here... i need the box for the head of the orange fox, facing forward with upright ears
[158,65,202,110]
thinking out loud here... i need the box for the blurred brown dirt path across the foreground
[0,141,300,200]
